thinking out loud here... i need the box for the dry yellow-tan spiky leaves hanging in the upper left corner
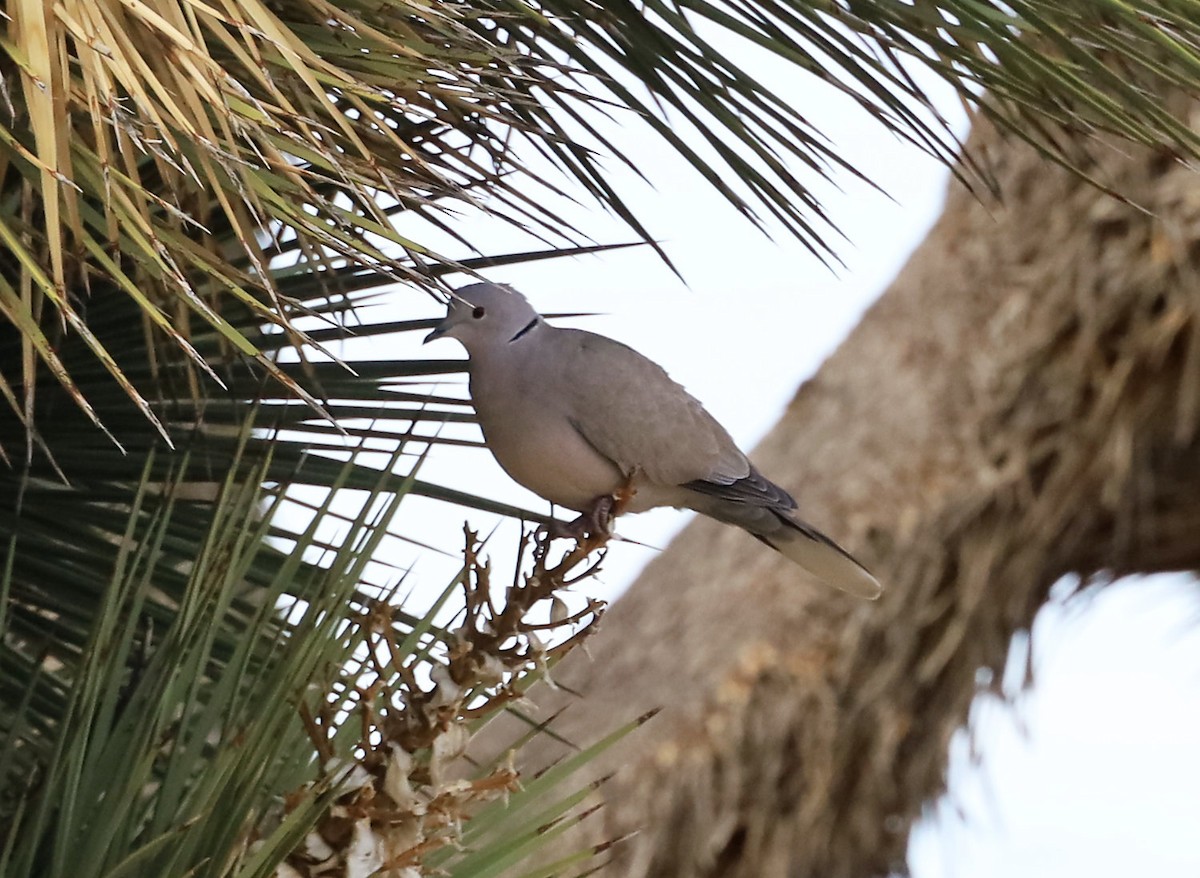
[0,0,590,435]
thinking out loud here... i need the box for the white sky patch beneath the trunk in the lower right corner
[908,576,1200,878]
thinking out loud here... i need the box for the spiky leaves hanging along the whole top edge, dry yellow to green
[0,0,1200,441]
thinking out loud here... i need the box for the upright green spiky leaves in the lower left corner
[0,441,384,876]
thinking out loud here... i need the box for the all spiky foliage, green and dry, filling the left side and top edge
[0,0,1200,874]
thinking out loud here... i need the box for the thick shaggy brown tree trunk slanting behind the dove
[472,101,1200,878]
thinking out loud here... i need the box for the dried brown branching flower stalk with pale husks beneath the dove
[277,508,631,878]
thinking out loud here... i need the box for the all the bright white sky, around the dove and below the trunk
[312,27,1200,878]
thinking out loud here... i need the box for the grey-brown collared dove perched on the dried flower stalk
[425,283,881,599]
